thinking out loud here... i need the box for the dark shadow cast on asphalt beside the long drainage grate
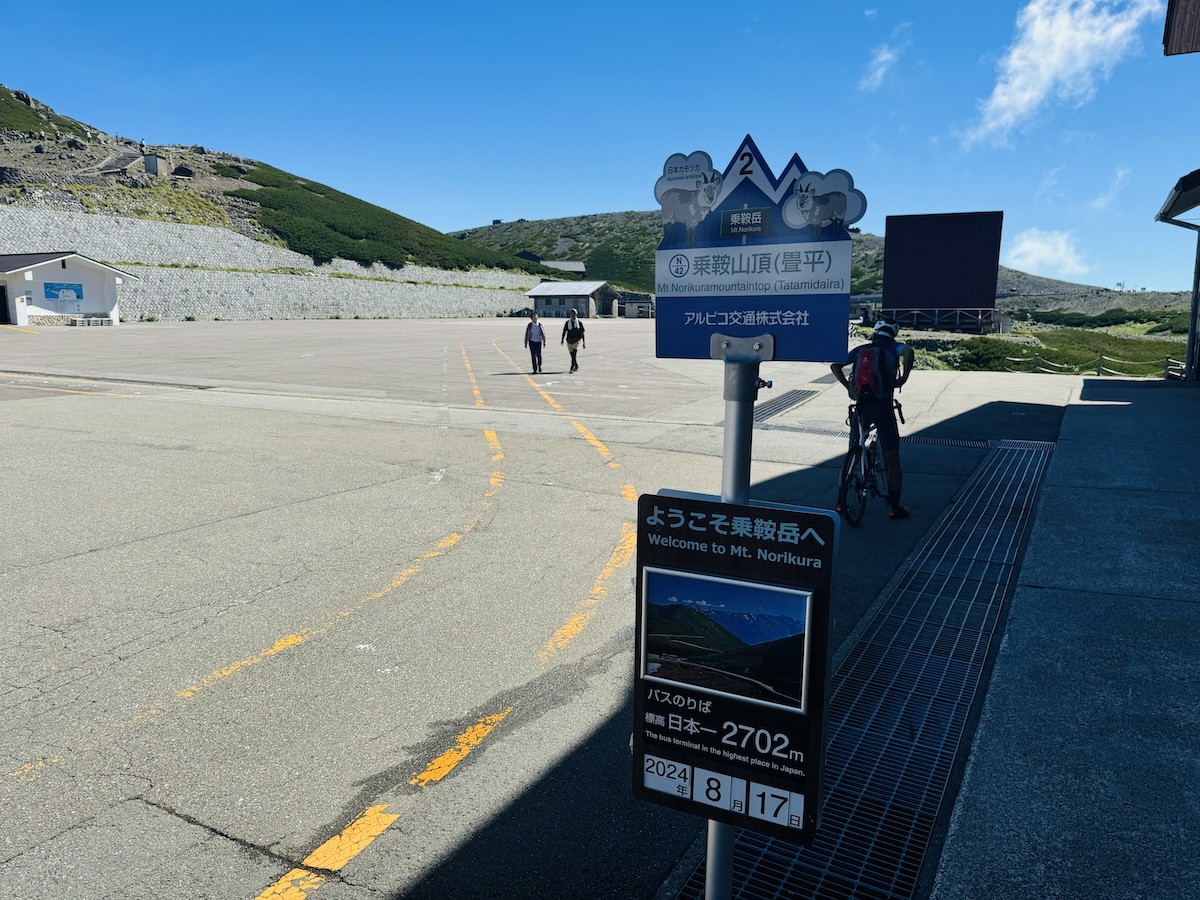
[391,402,1064,900]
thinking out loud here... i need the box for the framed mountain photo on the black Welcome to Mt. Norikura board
[641,566,811,710]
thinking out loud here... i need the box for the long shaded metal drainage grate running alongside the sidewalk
[678,442,1052,900]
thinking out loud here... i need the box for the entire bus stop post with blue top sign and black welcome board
[632,134,866,900]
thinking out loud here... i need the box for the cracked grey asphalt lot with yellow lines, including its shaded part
[0,319,1074,900]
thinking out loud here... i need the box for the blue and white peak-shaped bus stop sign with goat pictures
[654,134,866,362]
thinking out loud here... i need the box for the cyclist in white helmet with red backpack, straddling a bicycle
[829,319,913,518]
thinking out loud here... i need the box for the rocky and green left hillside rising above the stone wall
[0,85,563,278]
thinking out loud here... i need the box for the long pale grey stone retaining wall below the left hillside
[0,206,540,320]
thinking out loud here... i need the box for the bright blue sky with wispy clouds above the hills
[9,0,1200,290]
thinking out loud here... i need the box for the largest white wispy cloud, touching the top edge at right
[962,0,1163,146]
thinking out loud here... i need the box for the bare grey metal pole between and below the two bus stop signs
[704,334,775,900]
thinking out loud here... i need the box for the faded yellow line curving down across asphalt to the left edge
[7,427,499,781]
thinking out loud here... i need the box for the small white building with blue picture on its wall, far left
[0,251,137,325]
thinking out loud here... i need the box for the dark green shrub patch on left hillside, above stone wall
[212,163,562,277]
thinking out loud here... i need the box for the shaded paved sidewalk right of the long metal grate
[932,379,1200,900]
